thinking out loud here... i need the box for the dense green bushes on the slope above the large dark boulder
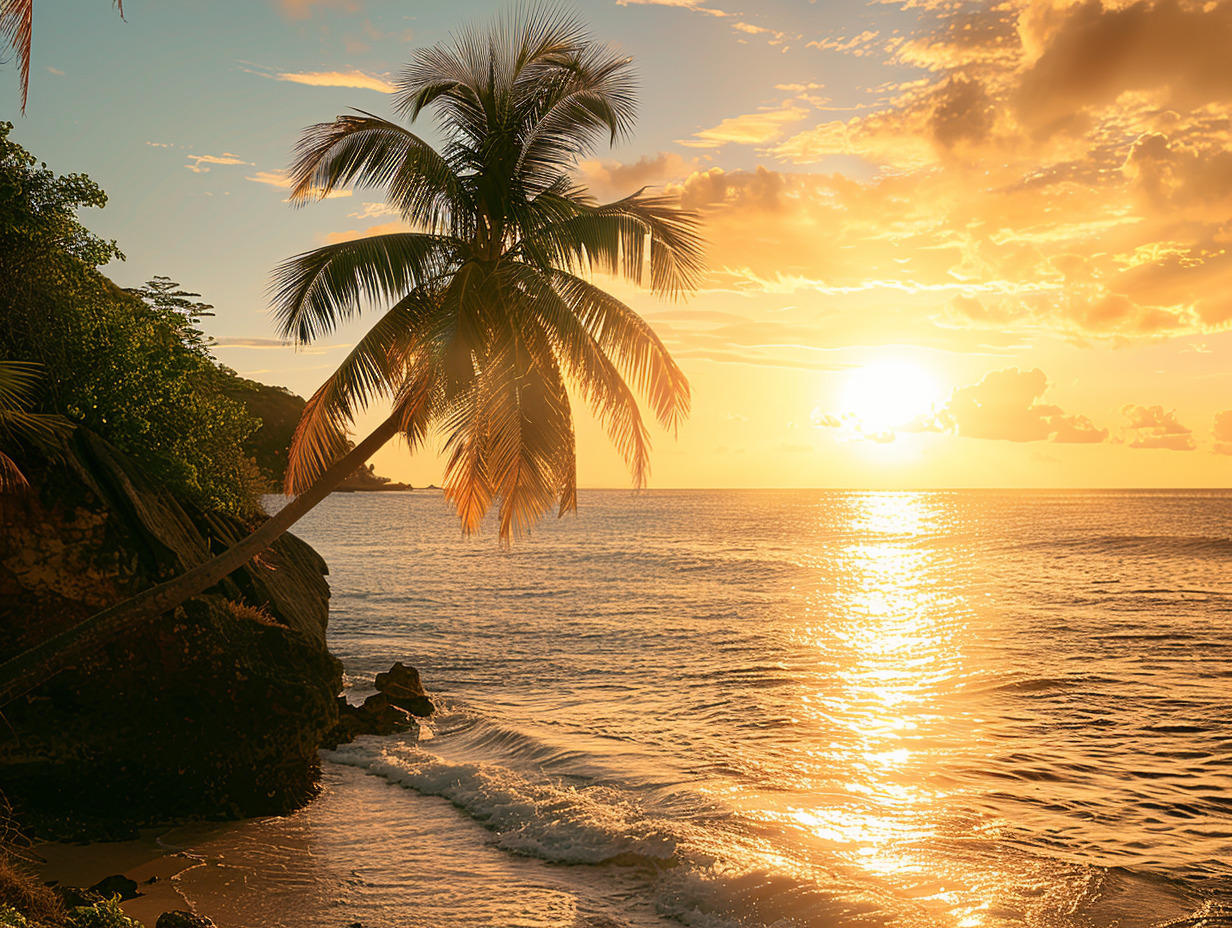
[0,123,260,514]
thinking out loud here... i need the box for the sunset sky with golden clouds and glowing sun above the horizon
[0,0,1232,488]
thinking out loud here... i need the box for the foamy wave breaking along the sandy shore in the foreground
[324,717,1232,928]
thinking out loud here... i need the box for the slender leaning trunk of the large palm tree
[0,414,399,706]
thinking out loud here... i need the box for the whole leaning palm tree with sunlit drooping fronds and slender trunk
[0,12,702,705]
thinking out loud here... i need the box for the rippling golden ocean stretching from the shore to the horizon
[158,490,1232,928]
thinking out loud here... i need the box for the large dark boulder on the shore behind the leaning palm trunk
[0,429,341,836]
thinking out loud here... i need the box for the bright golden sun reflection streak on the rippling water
[781,493,1005,928]
